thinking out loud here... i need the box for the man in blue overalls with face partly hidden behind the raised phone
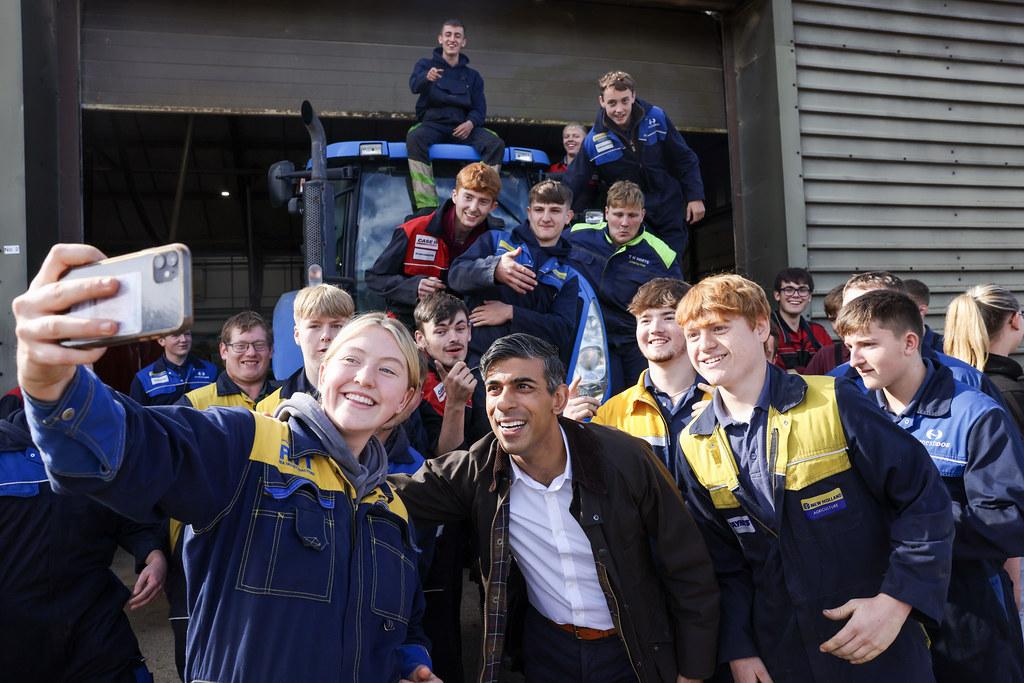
[129,330,217,405]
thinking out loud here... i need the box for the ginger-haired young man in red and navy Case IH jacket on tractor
[367,162,502,329]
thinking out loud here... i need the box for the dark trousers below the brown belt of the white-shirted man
[522,606,637,683]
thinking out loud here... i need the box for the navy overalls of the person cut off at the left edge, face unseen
[0,412,161,683]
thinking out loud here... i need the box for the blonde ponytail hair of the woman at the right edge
[943,285,1020,371]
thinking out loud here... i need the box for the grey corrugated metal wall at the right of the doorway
[780,0,1024,330]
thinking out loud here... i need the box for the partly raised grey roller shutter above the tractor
[82,0,725,132]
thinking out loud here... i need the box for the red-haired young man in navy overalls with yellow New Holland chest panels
[676,274,952,683]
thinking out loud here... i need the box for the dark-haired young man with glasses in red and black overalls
[771,268,833,373]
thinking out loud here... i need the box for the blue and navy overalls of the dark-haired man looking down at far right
[874,360,1024,683]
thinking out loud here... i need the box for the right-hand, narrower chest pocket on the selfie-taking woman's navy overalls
[367,504,419,624]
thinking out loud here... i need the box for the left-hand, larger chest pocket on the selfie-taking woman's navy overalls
[238,465,337,602]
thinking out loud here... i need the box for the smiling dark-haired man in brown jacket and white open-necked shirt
[391,334,719,683]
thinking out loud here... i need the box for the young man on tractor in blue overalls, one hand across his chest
[449,180,585,364]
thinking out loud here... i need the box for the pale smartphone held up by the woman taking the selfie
[61,244,193,348]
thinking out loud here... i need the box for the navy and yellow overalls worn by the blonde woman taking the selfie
[26,368,430,683]
